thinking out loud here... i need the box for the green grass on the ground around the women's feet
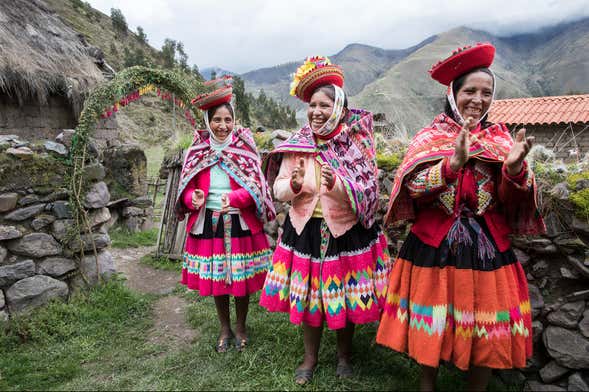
[0,280,515,390]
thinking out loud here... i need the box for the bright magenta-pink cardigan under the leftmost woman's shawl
[182,168,264,234]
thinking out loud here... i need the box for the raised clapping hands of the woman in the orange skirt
[450,117,534,176]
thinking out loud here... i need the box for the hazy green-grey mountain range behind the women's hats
[243,18,589,132]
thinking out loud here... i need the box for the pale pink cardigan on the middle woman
[274,154,358,238]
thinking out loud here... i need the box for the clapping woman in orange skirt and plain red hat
[377,44,544,390]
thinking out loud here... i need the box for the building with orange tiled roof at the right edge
[489,94,589,162]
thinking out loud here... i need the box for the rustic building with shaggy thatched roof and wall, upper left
[0,0,108,140]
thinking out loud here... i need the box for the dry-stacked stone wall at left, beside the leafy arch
[0,135,114,319]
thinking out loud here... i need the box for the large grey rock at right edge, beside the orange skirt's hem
[543,326,589,369]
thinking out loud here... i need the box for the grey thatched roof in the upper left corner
[0,0,103,114]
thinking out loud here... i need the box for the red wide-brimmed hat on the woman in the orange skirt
[429,43,495,86]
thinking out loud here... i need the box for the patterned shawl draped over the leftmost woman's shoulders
[175,128,276,221]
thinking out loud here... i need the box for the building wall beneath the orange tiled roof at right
[520,124,589,162]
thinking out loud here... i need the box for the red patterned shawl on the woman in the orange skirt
[384,113,545,234]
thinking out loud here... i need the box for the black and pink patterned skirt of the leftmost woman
[180,210,272,297]
